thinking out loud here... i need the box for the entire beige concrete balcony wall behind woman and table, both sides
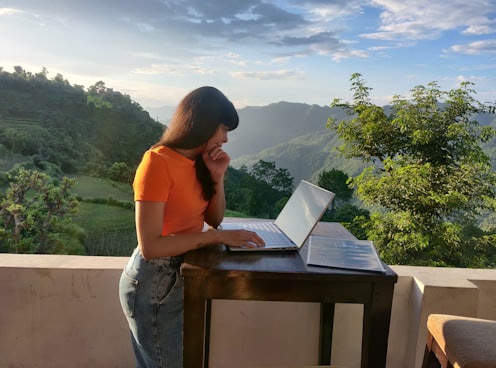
[0,254,496,368]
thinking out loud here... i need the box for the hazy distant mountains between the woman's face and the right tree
[147,102,496,182]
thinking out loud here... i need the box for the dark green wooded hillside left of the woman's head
[0,67,164,174]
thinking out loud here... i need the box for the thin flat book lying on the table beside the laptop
[307,236,386,273]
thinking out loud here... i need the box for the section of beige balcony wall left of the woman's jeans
[0,254,135,368]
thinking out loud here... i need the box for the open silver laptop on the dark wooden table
[221,180,335,252]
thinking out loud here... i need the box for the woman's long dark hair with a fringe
[153,86,239,200]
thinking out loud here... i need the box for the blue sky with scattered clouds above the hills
[0,0,496,108]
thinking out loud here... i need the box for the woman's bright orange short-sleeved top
[133,146,208,236]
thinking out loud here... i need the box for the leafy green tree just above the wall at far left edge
[0,168,83,254]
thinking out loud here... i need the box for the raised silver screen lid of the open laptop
[274,180,334,247]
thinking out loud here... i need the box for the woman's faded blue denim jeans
[119,248,183,368]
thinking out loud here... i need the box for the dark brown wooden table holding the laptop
[181,222,397,368]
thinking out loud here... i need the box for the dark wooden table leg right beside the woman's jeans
[183,277,210,368]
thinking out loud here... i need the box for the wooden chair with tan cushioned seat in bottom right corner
[422,314,496,368]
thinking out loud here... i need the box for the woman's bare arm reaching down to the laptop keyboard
[136,201,263,259]
